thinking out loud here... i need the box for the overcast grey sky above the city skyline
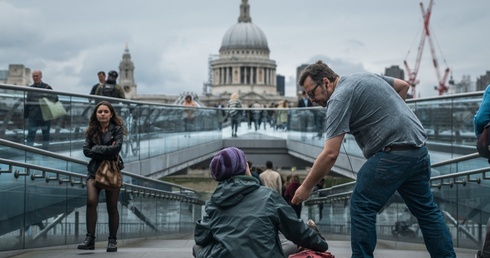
[0,0,490,97]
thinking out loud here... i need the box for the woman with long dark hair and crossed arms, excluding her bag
[78,101,126,252]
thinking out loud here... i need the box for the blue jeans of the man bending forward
[350,146,456,258]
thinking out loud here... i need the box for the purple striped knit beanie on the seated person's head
[209,147,247,181]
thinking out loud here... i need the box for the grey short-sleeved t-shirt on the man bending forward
[325,73,427,158]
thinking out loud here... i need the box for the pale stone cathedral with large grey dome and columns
[211,0,277,96]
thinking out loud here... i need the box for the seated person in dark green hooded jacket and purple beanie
[193,147,328,258]
